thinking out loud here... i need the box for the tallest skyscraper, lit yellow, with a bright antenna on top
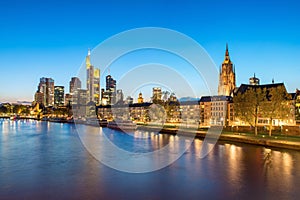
[85,50,100,104]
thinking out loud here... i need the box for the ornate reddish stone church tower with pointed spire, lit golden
[218,44,236,96]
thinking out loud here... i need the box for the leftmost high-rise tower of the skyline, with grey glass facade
[37,77,54,106]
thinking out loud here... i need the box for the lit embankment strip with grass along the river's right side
[138,126,300,151]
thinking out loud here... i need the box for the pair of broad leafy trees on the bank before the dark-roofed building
[233,86,292,136]
